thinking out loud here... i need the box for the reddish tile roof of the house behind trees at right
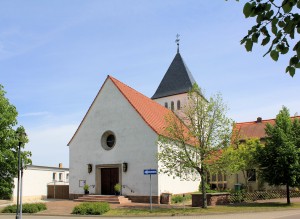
[235,116,300,140]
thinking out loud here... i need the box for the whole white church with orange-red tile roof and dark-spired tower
[68,48,199,202]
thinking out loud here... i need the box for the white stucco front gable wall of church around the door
[69,79,158,195]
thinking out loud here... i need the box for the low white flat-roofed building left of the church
[13,163,69,202]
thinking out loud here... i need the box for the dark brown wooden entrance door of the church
[101,168,119,195]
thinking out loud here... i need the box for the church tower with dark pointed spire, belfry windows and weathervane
[151,39,196,112]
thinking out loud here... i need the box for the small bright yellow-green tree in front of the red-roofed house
[220,139,262,190]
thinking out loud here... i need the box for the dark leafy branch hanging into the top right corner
[241,0,300,77]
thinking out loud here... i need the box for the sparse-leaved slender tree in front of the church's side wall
[158,84,231,208]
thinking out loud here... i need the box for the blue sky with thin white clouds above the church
[0,0,300,166]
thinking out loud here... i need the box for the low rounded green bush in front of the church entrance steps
[72,202,110,215]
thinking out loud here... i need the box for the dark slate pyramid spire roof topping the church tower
[152,51,195,99]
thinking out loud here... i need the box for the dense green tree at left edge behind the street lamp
[0,85,31,199]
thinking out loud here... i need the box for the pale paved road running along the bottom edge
[0,210,300,219]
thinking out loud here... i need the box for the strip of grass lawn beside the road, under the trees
[104,203,300,216]
